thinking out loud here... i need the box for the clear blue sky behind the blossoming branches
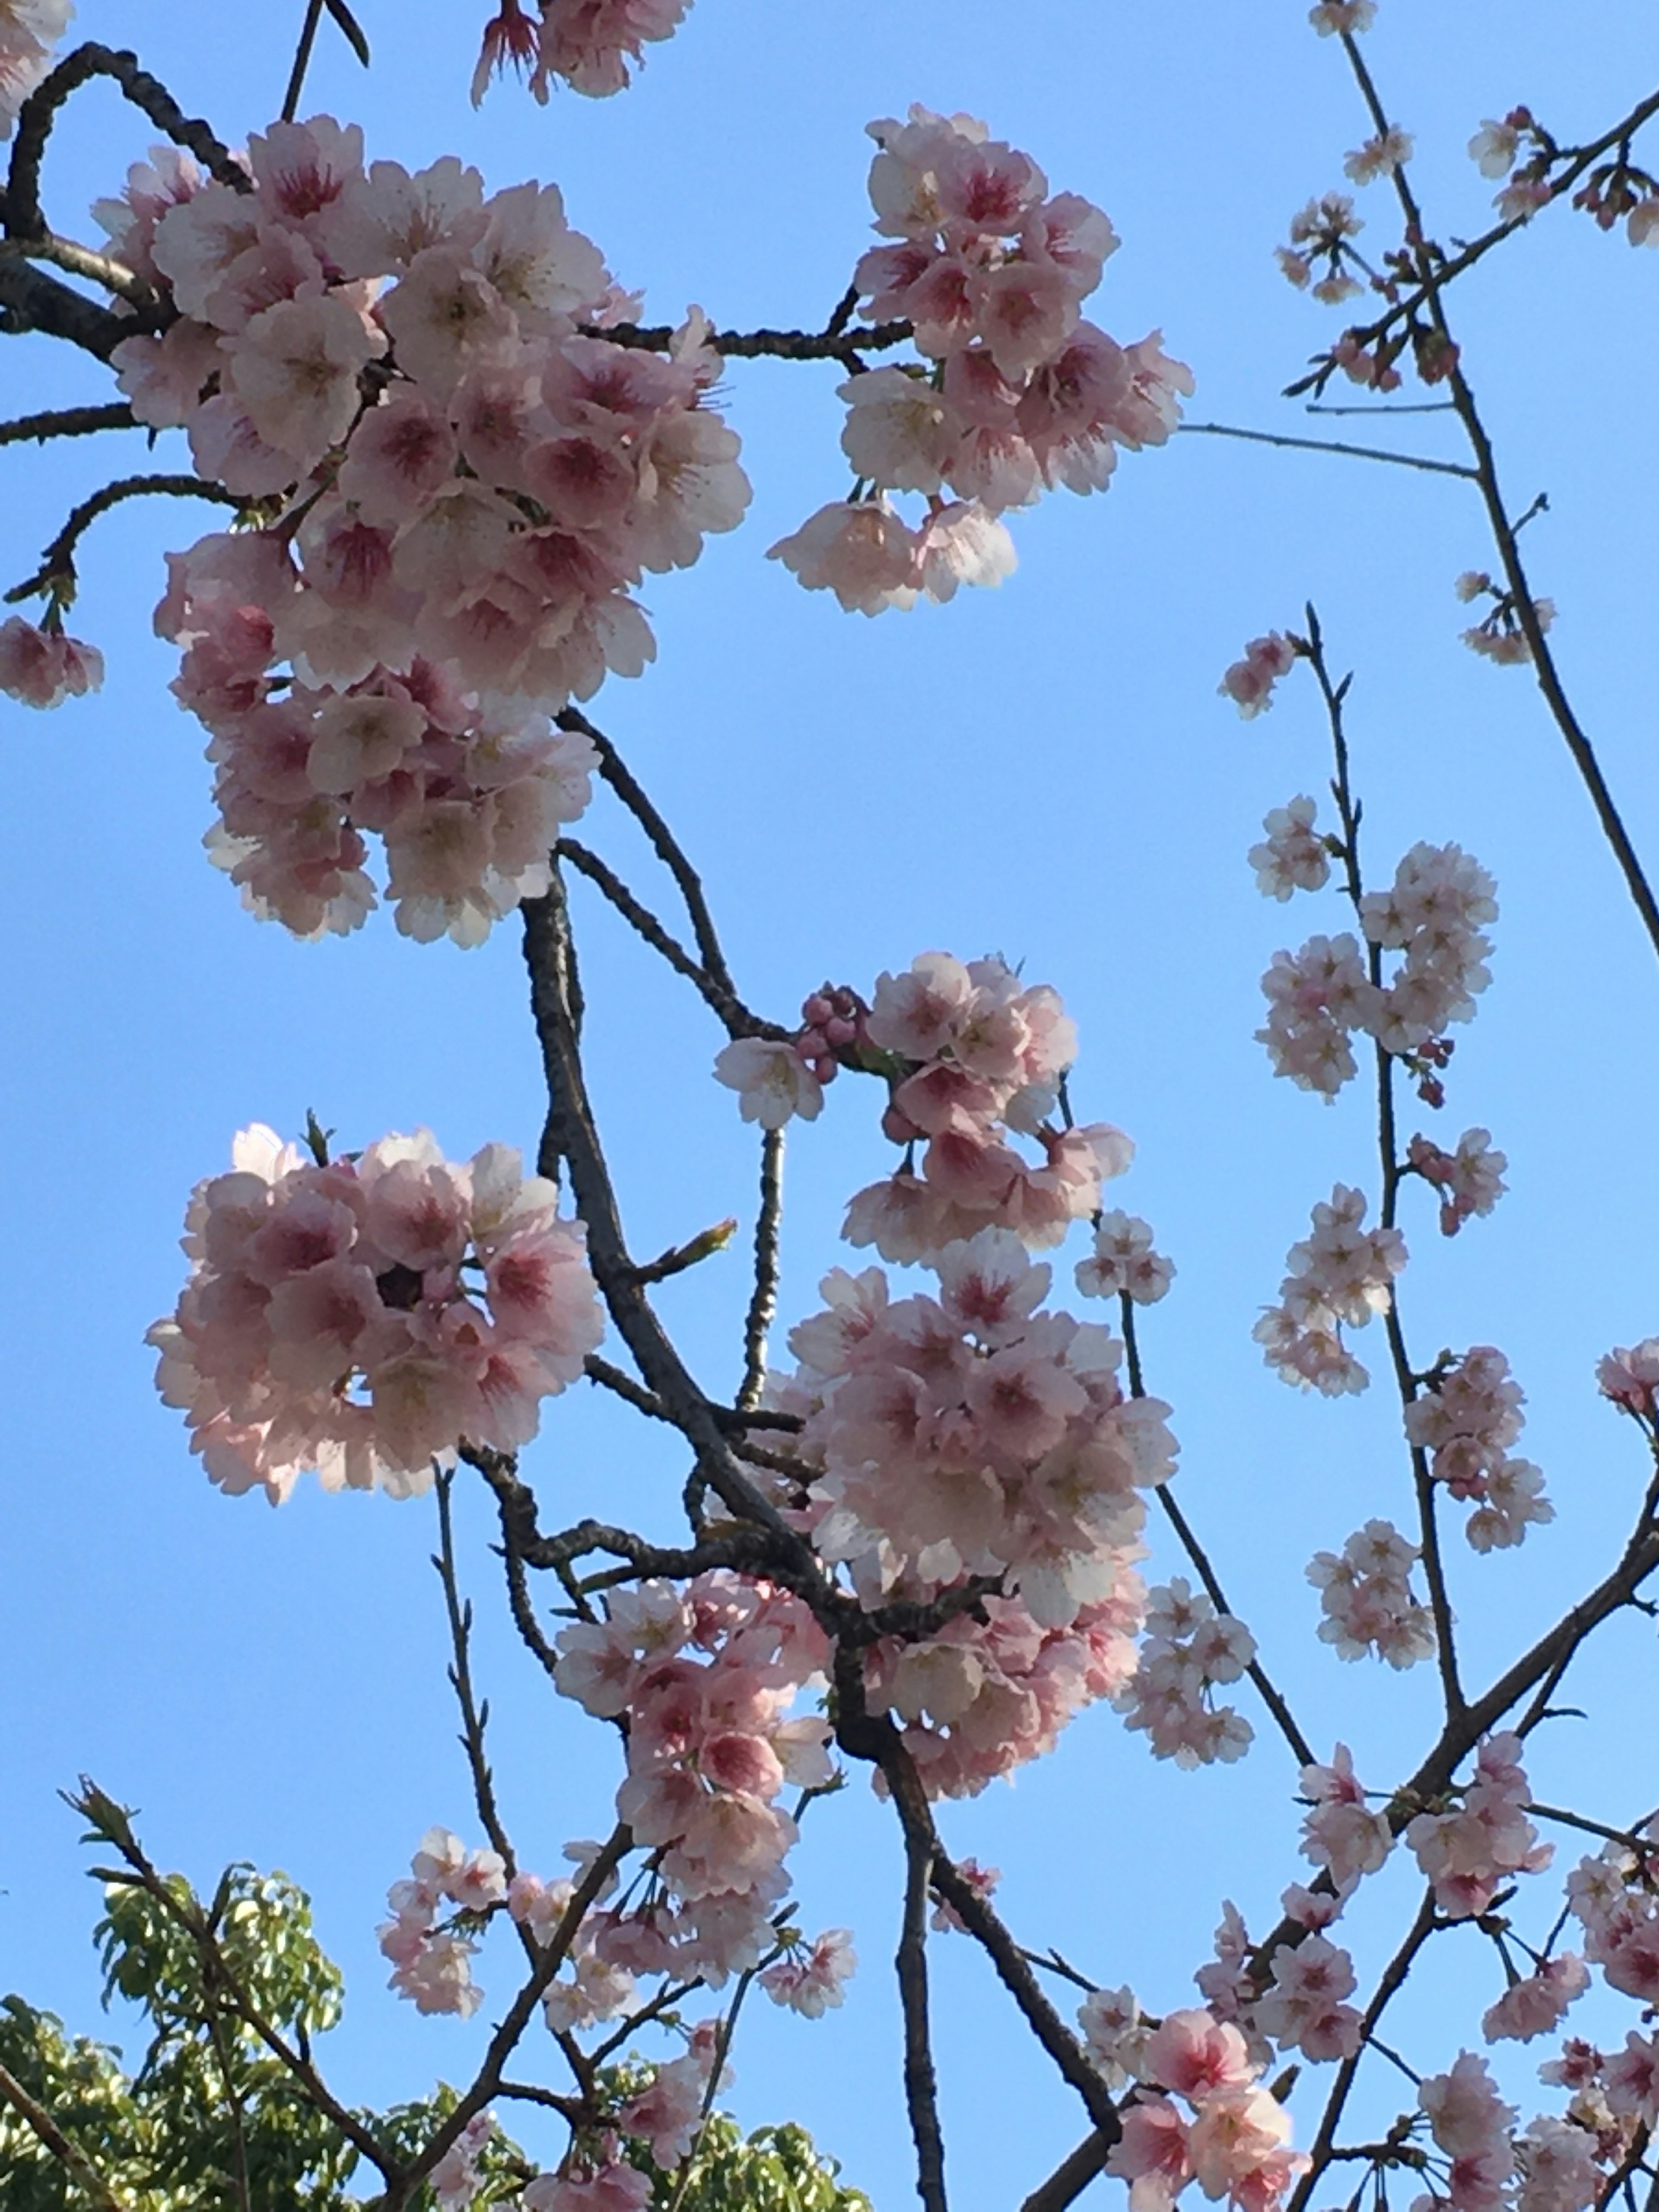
[0,0,1659,2206]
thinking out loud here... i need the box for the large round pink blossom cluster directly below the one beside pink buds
[790,1230,1175,1637]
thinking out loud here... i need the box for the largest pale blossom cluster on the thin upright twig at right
[1252,845,1497,1097]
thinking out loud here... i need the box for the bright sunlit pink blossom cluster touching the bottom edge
[1106,2009,1307,2212]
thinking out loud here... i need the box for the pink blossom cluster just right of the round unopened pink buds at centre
[843,953,1135,1265]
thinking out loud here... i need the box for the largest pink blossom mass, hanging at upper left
[97,117,748,942]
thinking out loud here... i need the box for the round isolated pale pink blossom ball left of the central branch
[148,1126,604,1504]
